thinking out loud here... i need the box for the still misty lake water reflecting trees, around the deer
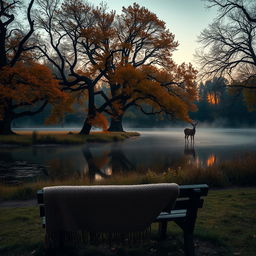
[0,128,256,184]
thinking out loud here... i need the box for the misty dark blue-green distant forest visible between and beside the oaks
[13,78,256,128]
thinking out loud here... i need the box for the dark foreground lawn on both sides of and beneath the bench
[0,188,256,256]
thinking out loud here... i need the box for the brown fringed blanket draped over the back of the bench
[44,183,179,245]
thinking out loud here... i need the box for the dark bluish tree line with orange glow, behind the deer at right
[191,78,256,127]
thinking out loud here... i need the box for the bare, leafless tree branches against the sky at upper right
[196,0,256,81]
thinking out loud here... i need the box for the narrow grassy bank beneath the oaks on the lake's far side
[0,132,139,146]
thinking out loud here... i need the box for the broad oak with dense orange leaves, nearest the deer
[84,4,196,131]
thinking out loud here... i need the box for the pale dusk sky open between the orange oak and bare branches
[93,0,216,65]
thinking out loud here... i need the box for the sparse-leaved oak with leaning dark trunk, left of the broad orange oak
[35,0,113,134]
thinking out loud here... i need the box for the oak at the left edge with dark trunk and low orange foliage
[0,0,67,134]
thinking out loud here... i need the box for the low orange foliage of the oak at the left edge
[0,61,71,122]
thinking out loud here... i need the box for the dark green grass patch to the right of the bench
[197,188,256,256]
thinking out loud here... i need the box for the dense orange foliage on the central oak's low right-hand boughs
[111,64,197,121]
